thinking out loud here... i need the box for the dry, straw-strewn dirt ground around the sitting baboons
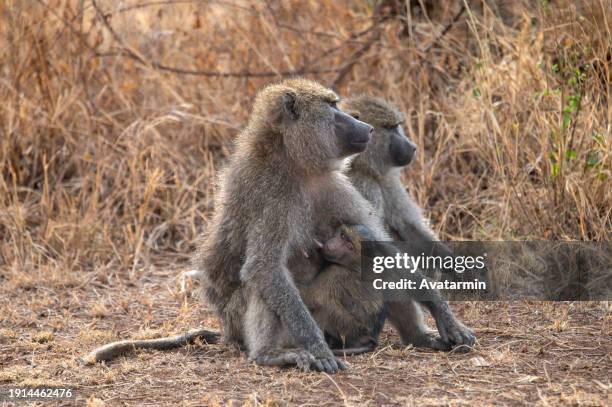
[0,266,612,406]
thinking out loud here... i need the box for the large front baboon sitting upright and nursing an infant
[196,79,382,372]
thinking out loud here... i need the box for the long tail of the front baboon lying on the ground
[82,329,221,365]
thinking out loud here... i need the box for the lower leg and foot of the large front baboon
[244,286,346,373]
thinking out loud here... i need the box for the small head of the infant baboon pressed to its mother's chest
[322,225,375,270]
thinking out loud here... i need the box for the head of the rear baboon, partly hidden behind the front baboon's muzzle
[341,96,416,175]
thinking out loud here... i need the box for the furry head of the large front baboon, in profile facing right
[238,79,373,171]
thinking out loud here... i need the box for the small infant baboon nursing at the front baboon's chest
[300,225,385,354]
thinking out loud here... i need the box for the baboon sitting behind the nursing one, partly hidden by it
[341,96,475,350]
